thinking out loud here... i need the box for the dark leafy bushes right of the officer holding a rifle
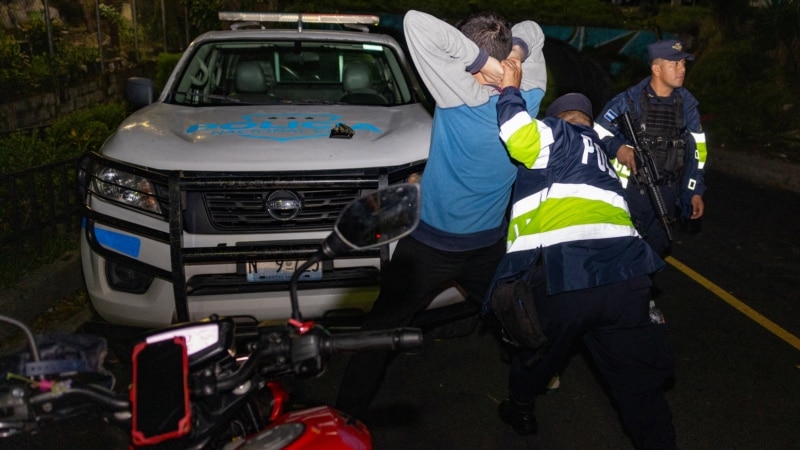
[686,5,800,146]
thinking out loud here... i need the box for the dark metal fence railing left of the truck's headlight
[0,159,79,248]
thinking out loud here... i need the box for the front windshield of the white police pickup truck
[169,40,413,106]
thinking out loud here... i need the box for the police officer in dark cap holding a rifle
[594,40,707,256]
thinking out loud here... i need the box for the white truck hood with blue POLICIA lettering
[102,103,431,172]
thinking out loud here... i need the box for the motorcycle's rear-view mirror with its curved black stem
[289,184,422,321]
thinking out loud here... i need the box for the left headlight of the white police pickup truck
[92,167,161,215]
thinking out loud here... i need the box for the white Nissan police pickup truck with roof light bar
[79,13,466,327]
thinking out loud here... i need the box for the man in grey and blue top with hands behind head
[336,10,547,420]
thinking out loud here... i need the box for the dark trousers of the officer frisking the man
[509,267,675,449]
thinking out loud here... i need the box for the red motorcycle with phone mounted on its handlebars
[0,184,422,450]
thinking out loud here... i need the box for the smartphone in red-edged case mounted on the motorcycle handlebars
[131,336,191,445]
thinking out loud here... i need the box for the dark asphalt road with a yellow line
[0,171,800,450]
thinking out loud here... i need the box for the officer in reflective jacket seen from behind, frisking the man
[487,82,675,449]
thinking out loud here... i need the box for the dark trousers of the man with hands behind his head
[336,237,505,420]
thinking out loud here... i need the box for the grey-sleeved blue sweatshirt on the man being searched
[404,10,547,251]
